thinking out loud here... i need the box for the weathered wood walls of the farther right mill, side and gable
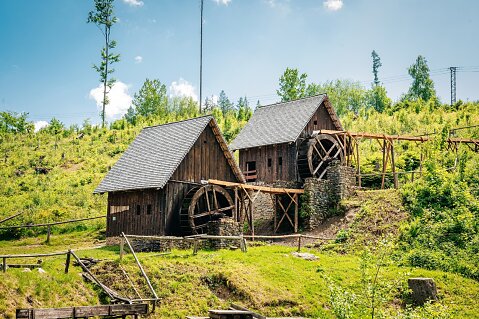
[239,103,336,183]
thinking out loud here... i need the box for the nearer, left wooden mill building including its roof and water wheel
[95,116,244,237]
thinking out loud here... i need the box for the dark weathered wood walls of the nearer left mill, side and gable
[107,126,242,237]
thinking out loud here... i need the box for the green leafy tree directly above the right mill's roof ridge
[276,68,308,102]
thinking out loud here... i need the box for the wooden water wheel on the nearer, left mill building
[180,185,235,234]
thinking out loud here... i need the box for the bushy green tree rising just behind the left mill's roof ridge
[132,79,168,117]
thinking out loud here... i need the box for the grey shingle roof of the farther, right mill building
[230,94,342,150]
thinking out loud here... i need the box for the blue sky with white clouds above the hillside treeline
[0,0,479,124]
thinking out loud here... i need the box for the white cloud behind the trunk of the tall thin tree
[90,81,132,119]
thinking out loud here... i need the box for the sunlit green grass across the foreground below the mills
[0,232,479,318]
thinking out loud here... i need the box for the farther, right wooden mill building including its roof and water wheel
[230,94,343,183]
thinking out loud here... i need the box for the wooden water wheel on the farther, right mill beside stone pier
[298,134,344,179]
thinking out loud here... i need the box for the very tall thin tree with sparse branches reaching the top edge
[87,0,120,127]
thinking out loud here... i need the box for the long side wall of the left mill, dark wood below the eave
[106,190,165,237]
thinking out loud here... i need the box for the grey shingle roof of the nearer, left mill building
[94,116,242,193]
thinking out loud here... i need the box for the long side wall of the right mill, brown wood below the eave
[239,143,296,183]
